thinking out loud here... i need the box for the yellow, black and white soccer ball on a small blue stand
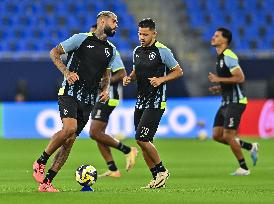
[75,165,97,186]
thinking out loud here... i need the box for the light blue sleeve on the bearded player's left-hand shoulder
[60,33,88,53]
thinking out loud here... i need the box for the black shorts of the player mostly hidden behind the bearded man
[91,102,115,123]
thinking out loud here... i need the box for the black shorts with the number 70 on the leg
[134,108,165,142]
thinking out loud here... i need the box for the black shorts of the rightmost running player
[213,103,246,130]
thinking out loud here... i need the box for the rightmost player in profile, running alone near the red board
[208,28,258,176]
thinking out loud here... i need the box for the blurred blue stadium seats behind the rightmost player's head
[182,0,274,52]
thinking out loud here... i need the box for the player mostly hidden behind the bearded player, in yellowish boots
[90,24,137,177]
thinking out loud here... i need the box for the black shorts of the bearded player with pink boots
[58,96,93,136]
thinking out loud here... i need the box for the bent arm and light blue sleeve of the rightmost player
[208,56,245,84]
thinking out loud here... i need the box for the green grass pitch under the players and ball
[0,139,274,204]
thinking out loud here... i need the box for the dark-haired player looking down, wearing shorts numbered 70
[123,18,183,188]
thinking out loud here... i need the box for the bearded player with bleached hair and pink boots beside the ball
[33,11,121,192]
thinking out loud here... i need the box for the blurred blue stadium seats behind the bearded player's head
[0,0,138,52]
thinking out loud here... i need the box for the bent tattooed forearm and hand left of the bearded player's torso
[50,44,79,85]
